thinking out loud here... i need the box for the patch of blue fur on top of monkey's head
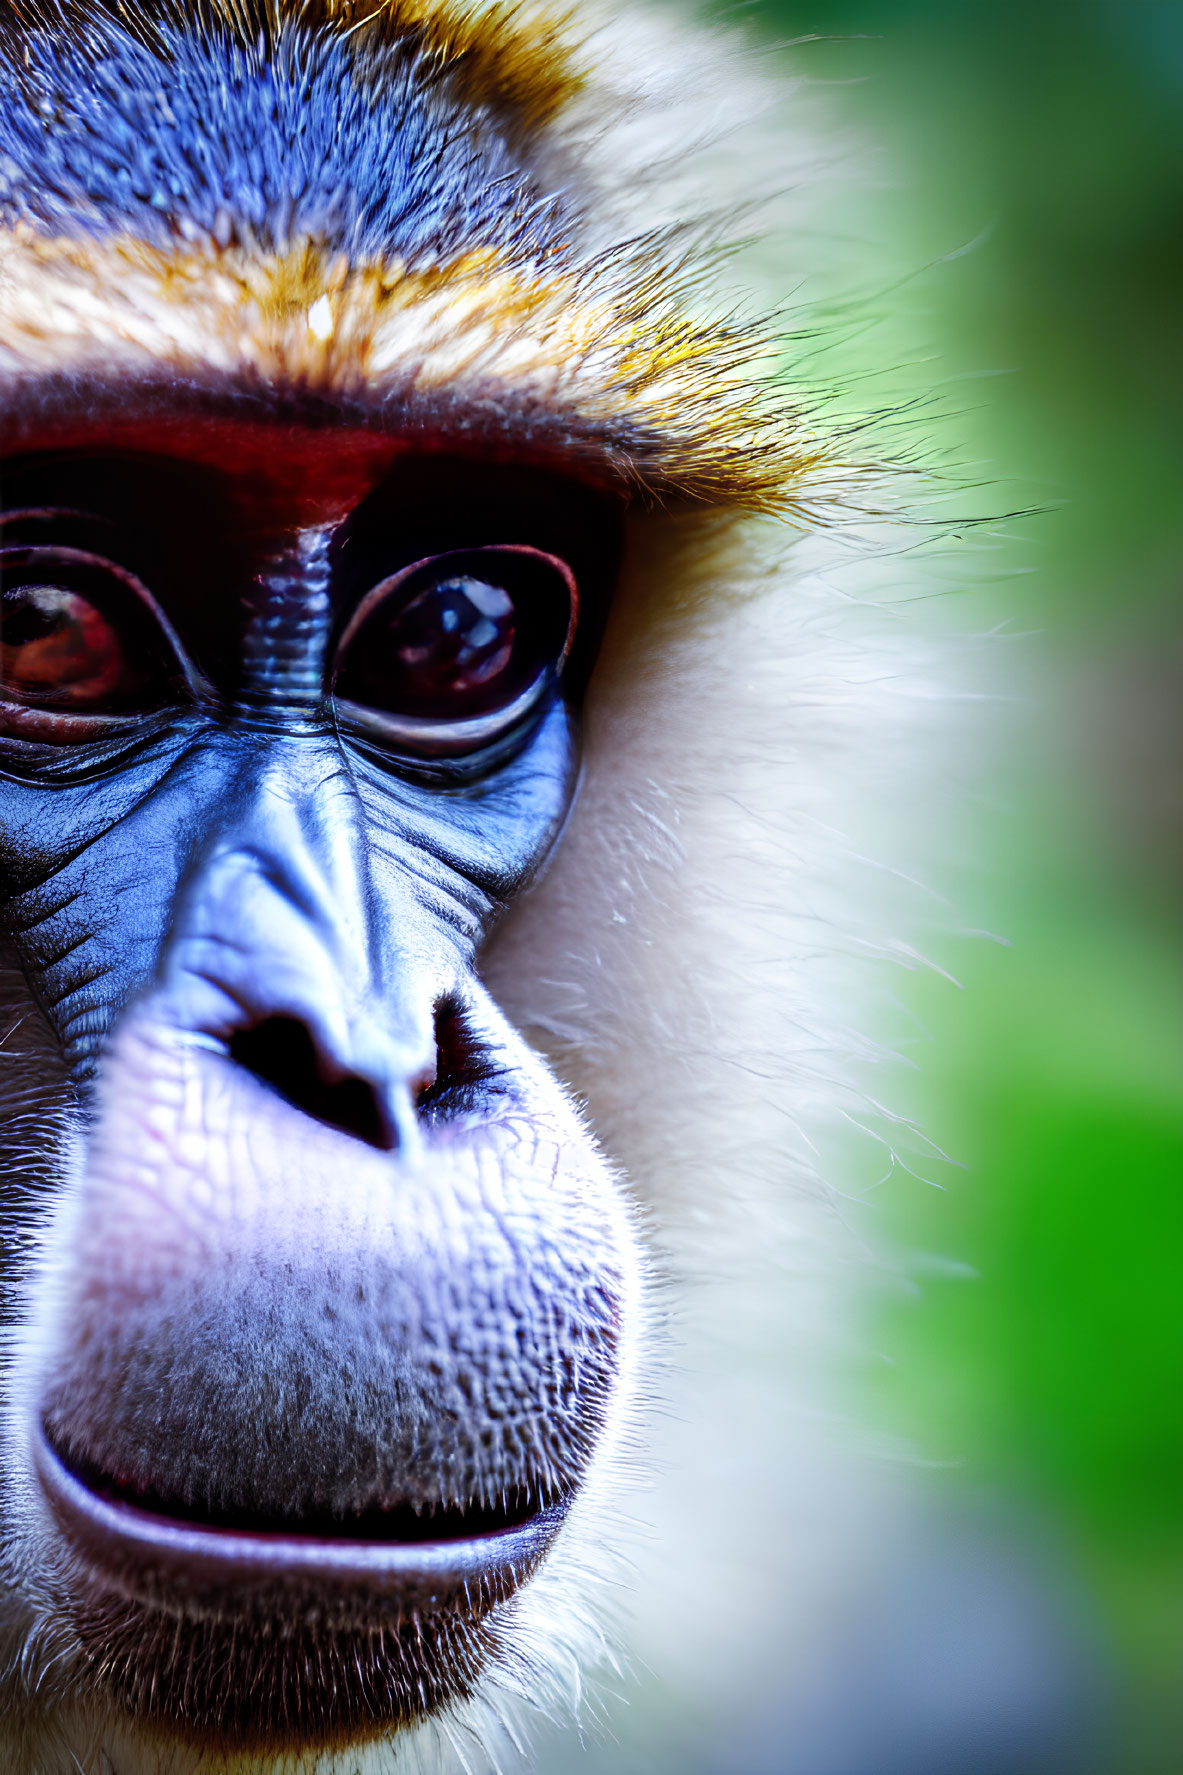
[0,20,558,264]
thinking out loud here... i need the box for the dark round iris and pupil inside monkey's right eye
[389,573,515,696]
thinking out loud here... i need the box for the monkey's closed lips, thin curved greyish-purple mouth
[36,1427,570,1608]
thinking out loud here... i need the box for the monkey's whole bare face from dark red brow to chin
[0,424,636,1747]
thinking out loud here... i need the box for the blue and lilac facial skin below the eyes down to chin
[0,489,636,1748]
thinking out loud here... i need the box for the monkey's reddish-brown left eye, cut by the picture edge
[0,548,178,738]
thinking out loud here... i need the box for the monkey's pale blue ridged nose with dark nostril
[148,742,439,1157]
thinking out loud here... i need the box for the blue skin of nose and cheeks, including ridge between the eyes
[0,458,593,1121]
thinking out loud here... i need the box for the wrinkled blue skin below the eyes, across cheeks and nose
[0,698,576,1086]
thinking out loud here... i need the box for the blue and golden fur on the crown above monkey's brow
[0,0,870,511]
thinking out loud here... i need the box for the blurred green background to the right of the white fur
[731,0,1183,1775]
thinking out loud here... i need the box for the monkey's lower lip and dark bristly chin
[34,1429,568,1754]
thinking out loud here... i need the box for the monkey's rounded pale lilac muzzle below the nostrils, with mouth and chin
[21,1019,629,1759]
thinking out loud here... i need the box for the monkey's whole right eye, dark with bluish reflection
[334,547,577,756]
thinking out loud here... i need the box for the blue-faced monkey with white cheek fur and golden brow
[0,0,930,1775]
